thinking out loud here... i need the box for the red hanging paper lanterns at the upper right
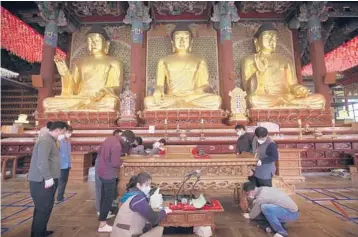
[302,36,358,76]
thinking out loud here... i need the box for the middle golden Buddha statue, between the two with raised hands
[144,31,222,110]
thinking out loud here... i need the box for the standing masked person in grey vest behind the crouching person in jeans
[253,127,278,187]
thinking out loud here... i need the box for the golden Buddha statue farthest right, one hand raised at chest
[241,23,326,109]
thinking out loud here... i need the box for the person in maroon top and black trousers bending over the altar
[96,130,135,233]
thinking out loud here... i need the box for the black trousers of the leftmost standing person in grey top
[30,179,58,237]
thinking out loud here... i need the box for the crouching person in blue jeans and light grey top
[243,182,298,237]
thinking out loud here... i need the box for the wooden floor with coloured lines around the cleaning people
[1,176,358,237]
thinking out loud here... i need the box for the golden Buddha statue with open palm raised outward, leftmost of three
[43,26,123,112]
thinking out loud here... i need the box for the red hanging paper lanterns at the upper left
[1,7,66,63]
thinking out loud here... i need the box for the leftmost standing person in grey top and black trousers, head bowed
[28,121,68,237]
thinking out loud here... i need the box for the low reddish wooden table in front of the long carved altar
[160,202,224,231]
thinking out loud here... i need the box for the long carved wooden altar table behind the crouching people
[118,154,294,195]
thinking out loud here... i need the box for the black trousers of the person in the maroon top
[99,177,116,221]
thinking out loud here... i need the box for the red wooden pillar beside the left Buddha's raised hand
[37,22,58,113]
